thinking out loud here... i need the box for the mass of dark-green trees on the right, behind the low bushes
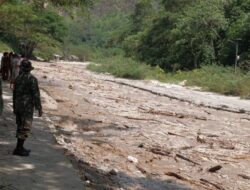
[121,0,250,70]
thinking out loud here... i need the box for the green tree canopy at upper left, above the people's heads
[0,4,66,57]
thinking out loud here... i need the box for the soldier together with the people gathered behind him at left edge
[0,52,43,156]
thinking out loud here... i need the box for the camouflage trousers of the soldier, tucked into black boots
[16,114,33,140]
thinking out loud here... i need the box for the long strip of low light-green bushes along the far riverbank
[88,56,250,98]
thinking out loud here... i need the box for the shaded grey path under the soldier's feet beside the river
[0,84,84,190]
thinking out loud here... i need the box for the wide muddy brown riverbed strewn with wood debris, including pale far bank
[27,63,250,190]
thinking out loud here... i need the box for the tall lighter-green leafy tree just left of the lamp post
[174,0,227,68]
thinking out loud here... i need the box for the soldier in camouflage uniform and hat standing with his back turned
[13,60,42,156]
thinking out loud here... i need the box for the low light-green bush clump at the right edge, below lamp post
[164,65,250,97]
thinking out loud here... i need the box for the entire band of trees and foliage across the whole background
[0,0,250,71]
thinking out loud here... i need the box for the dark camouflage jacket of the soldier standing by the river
[13,73,42,117]
